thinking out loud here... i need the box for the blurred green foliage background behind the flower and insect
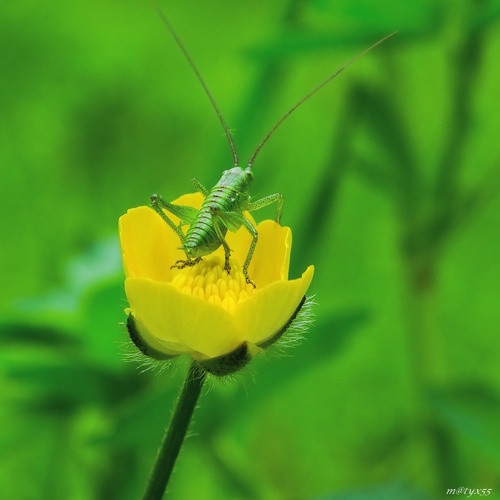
[0,0,500,500]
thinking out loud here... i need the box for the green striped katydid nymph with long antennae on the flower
[151,9,396,287]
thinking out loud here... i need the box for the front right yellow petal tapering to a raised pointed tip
[235,266,314,344]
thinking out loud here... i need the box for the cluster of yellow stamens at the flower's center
[172,255,254,312]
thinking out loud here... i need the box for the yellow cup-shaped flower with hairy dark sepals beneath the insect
[119,194,314,375]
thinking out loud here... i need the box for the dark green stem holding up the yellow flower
[143,362,207,500]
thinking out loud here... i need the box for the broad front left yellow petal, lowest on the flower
[125,278,241,359]
